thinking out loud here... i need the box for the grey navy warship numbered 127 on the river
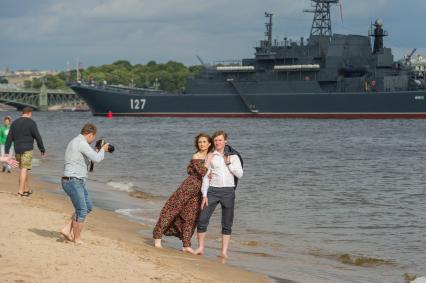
[71,0,426,119]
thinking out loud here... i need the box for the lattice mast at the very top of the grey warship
[304,0,339,37]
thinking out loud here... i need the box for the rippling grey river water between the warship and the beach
[4,112,426,283]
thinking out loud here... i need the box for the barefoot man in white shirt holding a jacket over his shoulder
[195,131,243,260]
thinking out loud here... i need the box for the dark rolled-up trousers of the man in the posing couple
[197,187,235,235]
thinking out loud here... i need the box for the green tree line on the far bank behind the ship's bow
[24,60,202,92]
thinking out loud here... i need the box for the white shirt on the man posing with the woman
[201,150,243,197]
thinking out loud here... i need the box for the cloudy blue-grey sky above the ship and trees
[0,0,426,70]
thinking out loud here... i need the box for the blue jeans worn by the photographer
[62,178,93,222]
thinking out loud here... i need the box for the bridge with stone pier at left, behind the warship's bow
[0,85,85,111]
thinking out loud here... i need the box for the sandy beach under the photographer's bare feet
[0,170,270,283]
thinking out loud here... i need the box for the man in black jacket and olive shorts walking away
[5,107,46,196]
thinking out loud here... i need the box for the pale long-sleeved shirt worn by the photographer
[64,134,105,179]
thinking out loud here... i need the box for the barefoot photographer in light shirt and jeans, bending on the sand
[61,124,109,244]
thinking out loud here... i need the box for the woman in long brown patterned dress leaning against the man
[153,133,212,253]
